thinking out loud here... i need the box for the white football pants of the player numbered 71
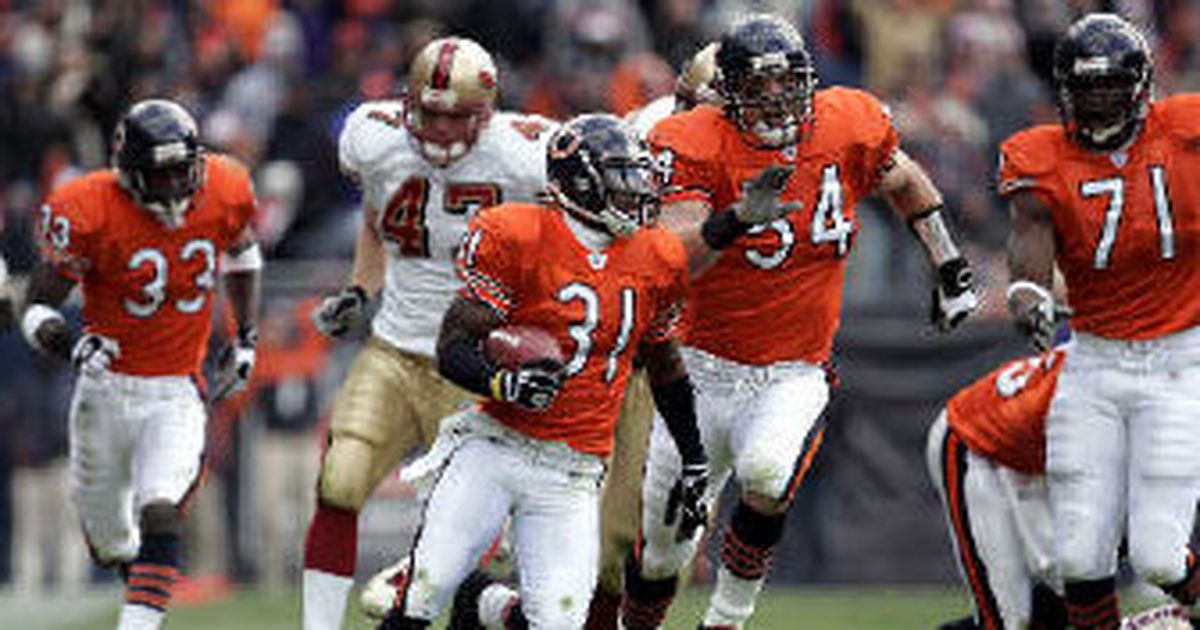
[1046,328,1200,586]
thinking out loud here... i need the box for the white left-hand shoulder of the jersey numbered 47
[337,101,408,180]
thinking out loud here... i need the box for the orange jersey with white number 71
[1000,95,1200,340]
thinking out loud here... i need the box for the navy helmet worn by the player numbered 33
[113,98,203,228]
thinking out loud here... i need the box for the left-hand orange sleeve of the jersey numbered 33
[34,192,94,282]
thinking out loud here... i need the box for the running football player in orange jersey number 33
[22,100,263,629]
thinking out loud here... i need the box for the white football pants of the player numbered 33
[70,372,205,563]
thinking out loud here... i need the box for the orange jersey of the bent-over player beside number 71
[946,349,1066,475]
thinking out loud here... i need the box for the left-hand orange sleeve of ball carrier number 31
[455,211,520,319]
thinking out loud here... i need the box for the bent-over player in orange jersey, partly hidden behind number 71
[925,349,1066,630]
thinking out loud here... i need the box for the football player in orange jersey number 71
[1000,13,1200,628]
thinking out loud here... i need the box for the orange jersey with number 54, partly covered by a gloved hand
[649,88,899,365]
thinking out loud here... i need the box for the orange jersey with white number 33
[37,155,254,377]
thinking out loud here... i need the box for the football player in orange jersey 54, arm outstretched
[622,16,977,629]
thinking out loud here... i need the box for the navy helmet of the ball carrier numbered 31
[546,114,661,236]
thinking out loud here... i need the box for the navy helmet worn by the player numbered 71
[1054,13,1153,151]
